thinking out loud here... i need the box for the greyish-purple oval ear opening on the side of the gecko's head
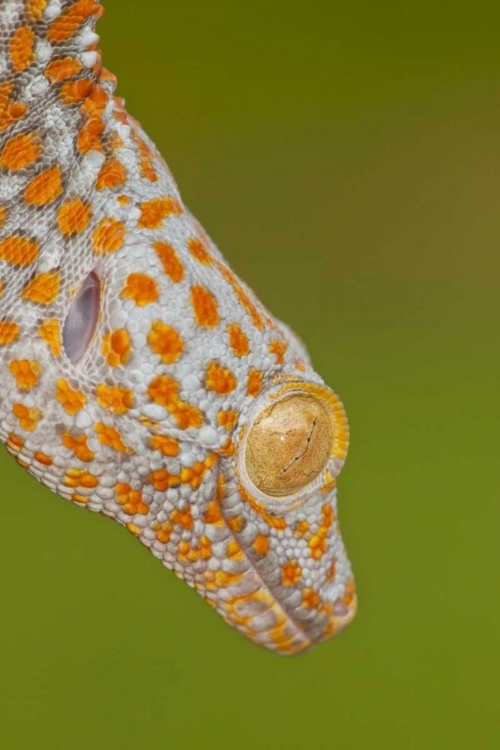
[62,271,101,364]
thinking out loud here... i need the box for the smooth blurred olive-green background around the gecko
[0,0,500,750]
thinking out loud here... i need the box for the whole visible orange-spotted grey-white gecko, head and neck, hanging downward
[0,0,356,654]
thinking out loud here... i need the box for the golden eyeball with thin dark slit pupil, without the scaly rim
[245,394,333,497]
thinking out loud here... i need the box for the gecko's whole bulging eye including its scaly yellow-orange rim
[239,383,349,513]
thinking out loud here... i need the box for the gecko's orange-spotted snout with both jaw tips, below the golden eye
[213,467,357,655]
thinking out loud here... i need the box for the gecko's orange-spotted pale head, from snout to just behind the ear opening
[1,199,356,654]
